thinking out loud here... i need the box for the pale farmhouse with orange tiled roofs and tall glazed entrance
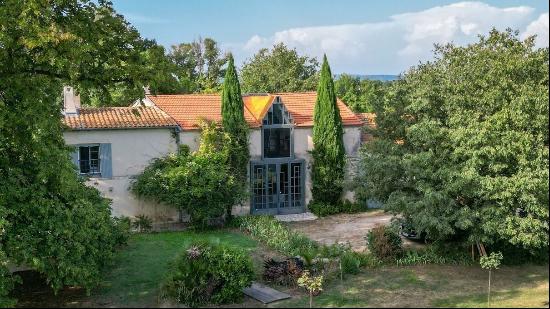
[64,87,365,221]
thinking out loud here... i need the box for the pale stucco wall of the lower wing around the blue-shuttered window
[63,129,179,222]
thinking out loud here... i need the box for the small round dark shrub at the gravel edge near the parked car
[366,225,403,262]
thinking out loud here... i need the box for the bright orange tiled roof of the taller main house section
[147,92,363,130]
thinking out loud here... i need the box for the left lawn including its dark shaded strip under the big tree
[11,230,262,307]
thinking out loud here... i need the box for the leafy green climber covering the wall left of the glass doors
[131,122,244,228]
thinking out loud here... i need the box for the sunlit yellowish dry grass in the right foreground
[275,265,548,308]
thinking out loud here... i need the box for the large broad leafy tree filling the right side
[357,30,549,251]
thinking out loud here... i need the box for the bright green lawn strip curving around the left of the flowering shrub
[91,231,257,307]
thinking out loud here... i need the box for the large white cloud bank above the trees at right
[233,2,548,74]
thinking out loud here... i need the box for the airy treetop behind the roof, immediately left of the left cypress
[168,38,228,93]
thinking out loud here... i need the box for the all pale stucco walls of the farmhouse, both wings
[64,127,361,222]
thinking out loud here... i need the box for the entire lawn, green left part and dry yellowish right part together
[14,230,548,307]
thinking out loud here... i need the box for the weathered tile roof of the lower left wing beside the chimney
[63,106,177,130]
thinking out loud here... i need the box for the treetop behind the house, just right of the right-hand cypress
[334,74,391,113]
